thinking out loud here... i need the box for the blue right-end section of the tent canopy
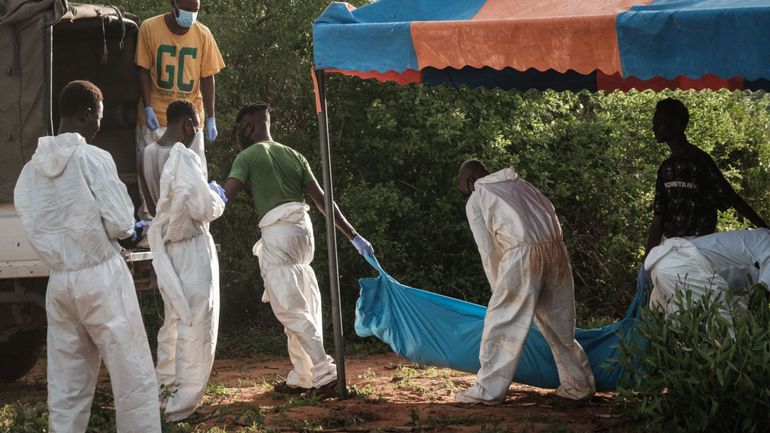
[616,0,770,81]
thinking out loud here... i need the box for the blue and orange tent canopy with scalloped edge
[313,0,770,90]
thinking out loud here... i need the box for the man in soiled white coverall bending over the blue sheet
[455,160,596,405]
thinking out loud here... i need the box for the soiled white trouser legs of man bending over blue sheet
[462,241,596,402]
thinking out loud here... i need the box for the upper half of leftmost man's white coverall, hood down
[13,134,134,271]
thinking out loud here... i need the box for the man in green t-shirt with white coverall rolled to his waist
[220,103,374,397]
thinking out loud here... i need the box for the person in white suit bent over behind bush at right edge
[644,228,770,320]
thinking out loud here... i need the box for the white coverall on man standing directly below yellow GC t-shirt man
[148,143,225,421]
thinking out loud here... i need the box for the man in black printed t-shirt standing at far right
[637,98,767,285]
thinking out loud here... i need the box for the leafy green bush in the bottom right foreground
[620,285,770,432]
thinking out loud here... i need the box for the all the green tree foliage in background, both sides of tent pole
[100,0,770,335]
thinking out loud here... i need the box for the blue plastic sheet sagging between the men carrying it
[355,257,644,391]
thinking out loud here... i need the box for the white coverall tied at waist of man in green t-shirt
[254,202,337,388]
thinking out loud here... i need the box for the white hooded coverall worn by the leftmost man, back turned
[14,133,161,433]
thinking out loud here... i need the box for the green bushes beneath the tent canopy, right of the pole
[316,83,770,323]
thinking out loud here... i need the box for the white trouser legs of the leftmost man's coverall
[46,255,161,433]
